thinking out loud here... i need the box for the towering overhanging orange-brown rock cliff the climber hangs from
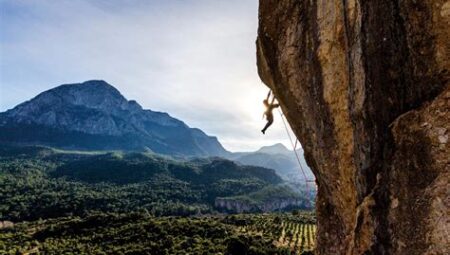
[257,0,450,254]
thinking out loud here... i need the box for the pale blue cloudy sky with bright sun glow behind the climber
[0,0,296,151]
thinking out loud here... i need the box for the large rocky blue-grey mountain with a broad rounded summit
[0,80,228,156]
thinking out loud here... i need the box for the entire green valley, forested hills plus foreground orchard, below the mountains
[0,147,315,255]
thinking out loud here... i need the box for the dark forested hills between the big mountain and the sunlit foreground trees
[0,146,308,222]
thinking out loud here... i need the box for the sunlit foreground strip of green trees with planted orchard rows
[0,211,315,255]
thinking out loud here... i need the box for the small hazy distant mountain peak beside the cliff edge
[229,143,314,182]
